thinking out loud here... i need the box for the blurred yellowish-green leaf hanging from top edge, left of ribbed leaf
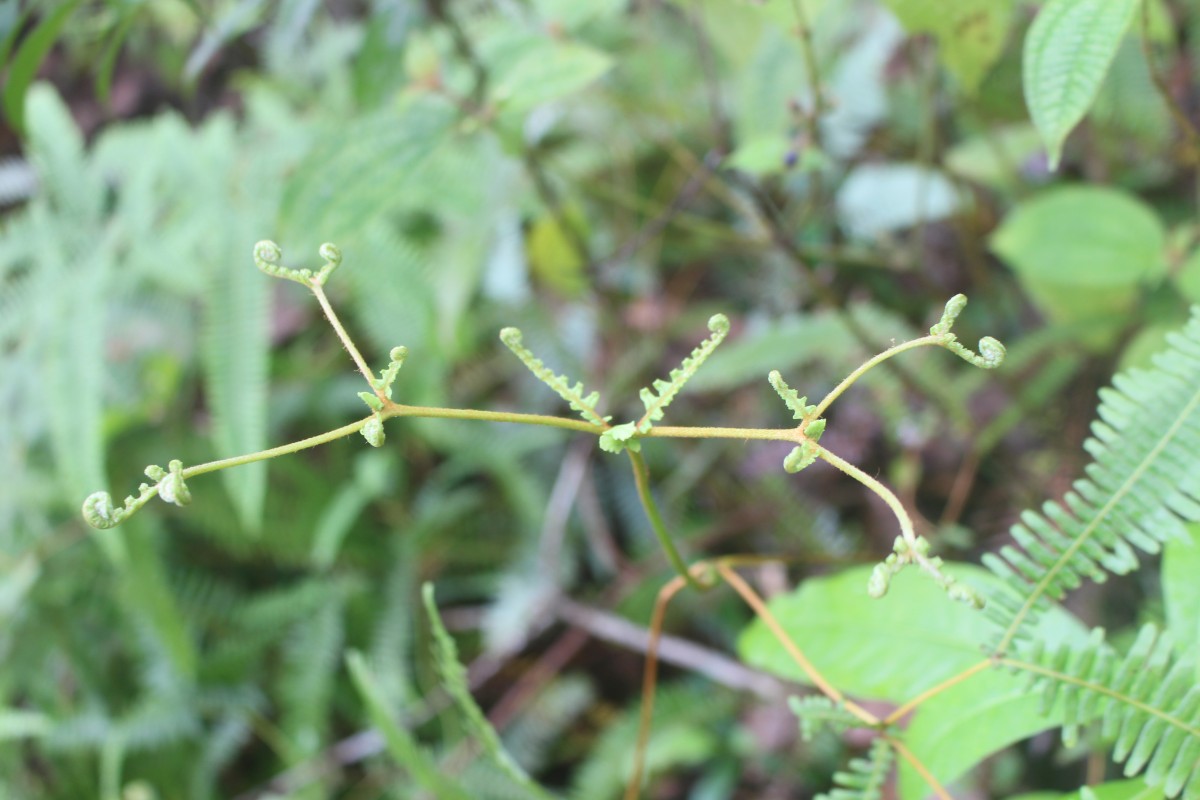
[884,0,1013,95]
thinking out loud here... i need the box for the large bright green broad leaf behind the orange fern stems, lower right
[738,564,1087,798]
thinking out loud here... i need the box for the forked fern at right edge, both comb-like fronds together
[984,307,1200,799]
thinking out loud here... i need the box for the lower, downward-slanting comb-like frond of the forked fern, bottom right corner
[1001,625,1200,800]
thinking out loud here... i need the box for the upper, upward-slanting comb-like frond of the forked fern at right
[984,308,1200,655]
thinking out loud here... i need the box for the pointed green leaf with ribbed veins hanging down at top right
[1024,0,1139,169]
